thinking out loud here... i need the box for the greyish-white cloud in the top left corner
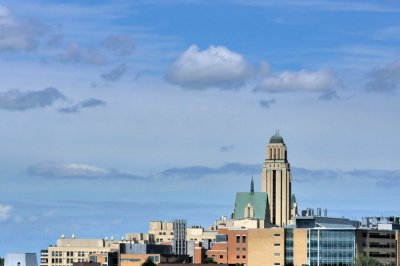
[0,5,43,51]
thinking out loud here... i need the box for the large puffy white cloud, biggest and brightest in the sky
[166,45,262,90]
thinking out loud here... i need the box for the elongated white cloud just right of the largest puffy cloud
[255,69,341,92]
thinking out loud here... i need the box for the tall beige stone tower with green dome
[261,133,292,227]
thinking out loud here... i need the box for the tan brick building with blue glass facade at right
[247,216,358,266]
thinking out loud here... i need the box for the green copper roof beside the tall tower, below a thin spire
[233,192,268,220]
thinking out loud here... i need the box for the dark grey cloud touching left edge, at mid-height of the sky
[0,88,66,111]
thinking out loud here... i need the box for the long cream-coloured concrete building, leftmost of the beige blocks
[40,236,119,266]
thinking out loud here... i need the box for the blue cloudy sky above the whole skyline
[0,0,400,256]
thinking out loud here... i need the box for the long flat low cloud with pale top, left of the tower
[27,162,142,179]
